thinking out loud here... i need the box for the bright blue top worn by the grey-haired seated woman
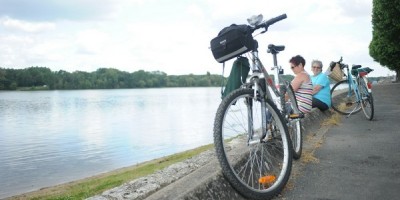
[311,73,331,107]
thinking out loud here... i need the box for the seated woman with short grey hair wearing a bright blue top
[311,60,331,111]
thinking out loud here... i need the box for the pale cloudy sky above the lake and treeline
[0,0,395,76]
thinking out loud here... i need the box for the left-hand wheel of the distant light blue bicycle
[331,80,361,115]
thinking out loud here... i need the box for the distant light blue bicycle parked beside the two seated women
[331,58,374,120]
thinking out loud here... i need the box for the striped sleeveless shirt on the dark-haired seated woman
[295,76,313,113]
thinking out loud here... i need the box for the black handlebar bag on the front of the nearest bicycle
[210,24,255,63]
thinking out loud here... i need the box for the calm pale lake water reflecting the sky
[0,88,221,198]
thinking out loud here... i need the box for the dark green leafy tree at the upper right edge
[369,0,400,81]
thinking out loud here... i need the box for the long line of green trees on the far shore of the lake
[0,67,222,90]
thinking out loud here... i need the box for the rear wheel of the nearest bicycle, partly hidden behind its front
[286,84,303,160]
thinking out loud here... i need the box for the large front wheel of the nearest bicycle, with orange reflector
[214,88,292,199]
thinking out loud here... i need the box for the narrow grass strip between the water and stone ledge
[10,144,213,200]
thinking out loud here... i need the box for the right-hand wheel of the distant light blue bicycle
[358,78,374,121]
